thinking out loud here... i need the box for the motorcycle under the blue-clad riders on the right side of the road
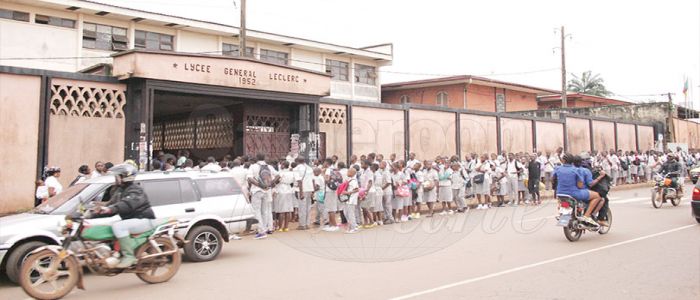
[557,195,612,242]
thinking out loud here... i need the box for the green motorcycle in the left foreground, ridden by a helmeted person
[19,212,184,299]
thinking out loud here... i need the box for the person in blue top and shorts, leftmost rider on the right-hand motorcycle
[553,153,601,226]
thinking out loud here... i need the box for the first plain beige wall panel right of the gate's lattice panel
[352,106,404,157]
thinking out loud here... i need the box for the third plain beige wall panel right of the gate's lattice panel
[459,114,498,157]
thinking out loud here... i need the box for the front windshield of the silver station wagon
[32,183,105,215]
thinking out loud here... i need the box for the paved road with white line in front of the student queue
[0,183,700,299]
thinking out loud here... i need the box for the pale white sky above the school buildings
[94,0,700,109]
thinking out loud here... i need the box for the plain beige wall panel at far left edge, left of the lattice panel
[0,73,41,214]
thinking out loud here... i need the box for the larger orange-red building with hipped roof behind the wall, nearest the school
[382,75,558,112]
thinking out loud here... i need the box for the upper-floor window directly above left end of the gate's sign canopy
[83,22,129,51]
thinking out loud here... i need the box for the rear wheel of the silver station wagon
[184,225,223,262]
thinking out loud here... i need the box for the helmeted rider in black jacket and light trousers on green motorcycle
[98,162,156,268]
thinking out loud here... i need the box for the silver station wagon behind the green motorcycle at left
[0,172,254,282]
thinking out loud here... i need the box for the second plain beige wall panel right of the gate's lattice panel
[408,109,457,160]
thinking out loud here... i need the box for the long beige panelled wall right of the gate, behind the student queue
[319,99,660,160]
